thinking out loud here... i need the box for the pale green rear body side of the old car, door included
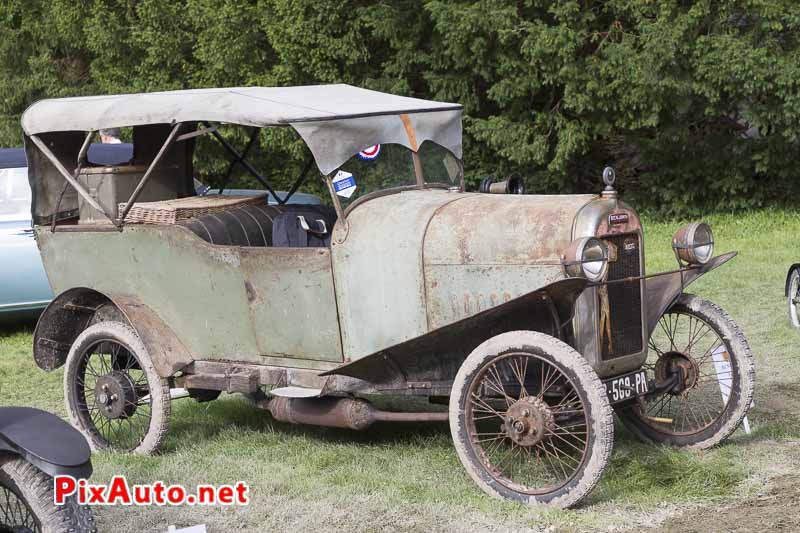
[37,224,342,368]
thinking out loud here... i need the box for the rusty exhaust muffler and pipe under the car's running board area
[261,396,448,431]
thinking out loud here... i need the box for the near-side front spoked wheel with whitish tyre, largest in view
[450,331,614,507]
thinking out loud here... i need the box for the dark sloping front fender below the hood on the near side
[322,278,588,388]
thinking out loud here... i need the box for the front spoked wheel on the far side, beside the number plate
[620,294,755,449]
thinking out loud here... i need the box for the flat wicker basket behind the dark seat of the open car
[119,194,267,224]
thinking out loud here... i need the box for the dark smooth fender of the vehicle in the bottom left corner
[0,407,92,478]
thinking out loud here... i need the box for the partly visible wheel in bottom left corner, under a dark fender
[0,455,97,533]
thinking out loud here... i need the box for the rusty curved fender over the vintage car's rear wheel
[33,287,193,378]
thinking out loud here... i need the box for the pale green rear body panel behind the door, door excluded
[37,225,259,360]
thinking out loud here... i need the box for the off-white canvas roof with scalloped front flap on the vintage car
[22,84,462,175]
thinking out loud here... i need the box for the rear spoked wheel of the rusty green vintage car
[64,322,170,454]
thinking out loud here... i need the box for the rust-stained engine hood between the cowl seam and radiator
[424,194,594,329]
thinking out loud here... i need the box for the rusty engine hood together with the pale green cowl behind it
[332,190,594,360]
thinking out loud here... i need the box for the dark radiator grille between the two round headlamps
[598,233,643,360]
